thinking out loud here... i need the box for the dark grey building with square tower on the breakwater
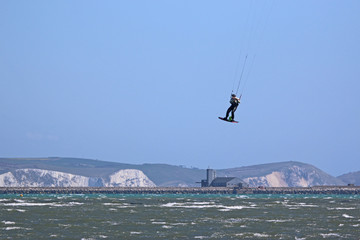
[201,169,247,188]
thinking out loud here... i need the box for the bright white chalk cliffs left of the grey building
[0,169,156,187]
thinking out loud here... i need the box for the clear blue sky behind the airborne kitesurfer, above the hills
[0,0,360,176]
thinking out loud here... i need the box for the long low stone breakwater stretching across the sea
[0,186,360,194]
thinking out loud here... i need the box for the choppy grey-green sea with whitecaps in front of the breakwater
[0,195,360,239]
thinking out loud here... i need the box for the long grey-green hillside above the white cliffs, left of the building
[0,157,206,186]
